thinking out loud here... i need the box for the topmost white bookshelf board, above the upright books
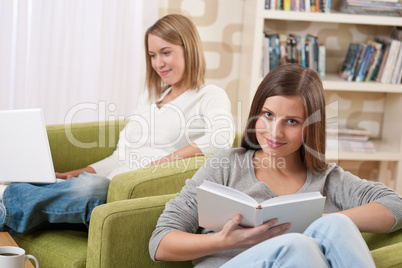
[262,10,402,26]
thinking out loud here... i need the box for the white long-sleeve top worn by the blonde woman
[90,85,234,179]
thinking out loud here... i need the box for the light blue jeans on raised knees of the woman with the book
[222,214,375,268]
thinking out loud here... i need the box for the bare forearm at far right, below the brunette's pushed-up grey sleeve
[339,202,396,233]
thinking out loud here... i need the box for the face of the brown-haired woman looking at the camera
[255,96,306,158]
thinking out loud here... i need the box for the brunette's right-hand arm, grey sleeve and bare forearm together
[325,167,402,233]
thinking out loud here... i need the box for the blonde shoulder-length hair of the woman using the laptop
[145,14,206,98]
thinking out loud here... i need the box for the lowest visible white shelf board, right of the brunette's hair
[325,140,402,161]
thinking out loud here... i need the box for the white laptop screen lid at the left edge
[0,109,56,183]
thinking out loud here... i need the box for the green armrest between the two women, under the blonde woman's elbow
[107,156,208,203]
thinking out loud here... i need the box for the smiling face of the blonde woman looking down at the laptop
[148,34,186,90]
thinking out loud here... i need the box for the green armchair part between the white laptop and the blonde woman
[46,121,125,172]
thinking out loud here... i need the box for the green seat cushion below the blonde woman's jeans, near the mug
[14,230,88,268]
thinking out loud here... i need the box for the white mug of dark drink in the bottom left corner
[0,247,39,268]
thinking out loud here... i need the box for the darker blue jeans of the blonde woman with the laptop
[0,172,110,235]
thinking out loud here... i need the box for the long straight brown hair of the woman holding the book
[241,64,327,174]
